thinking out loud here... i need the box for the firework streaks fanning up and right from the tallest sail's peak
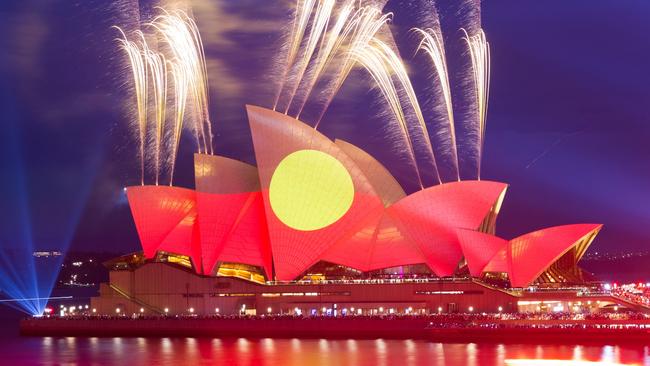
[273,0,391,127]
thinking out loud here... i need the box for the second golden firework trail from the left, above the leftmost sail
[143,43,167,185]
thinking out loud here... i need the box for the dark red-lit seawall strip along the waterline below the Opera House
[20,318,650,344]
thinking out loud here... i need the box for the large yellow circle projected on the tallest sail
[269,150,354,231]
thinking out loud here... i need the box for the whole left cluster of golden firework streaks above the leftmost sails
[115,9,213,185]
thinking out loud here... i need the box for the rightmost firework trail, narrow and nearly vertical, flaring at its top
[462,29,490,180]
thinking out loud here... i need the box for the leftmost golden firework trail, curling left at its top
[114,27,147,185]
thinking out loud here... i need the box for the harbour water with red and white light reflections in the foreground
[15,337,650,366]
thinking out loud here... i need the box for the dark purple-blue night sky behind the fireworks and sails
[0,0,650,258]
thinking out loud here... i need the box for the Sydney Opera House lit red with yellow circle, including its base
[92,106,601,315]
